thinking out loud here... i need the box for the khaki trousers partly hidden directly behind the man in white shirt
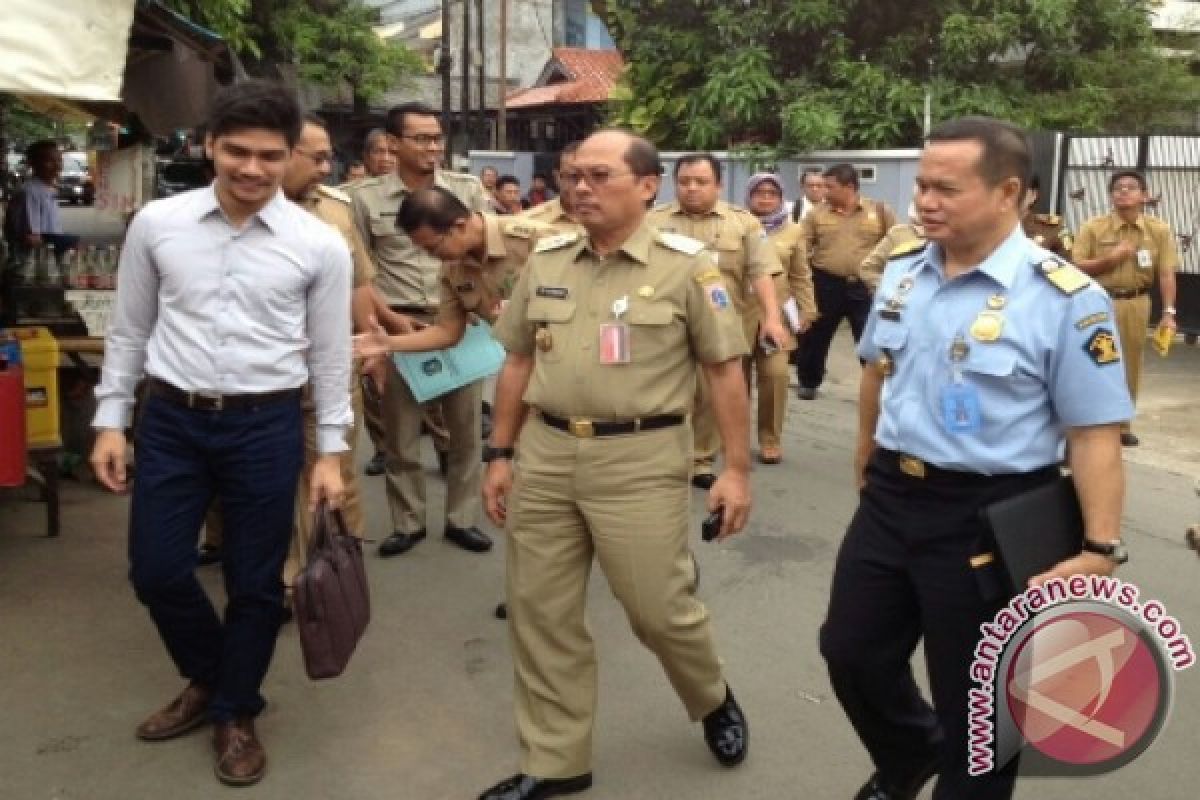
[202,368,366,587]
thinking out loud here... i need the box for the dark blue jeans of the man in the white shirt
[130,396,304,721]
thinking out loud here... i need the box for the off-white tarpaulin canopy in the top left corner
[0,0,136,102]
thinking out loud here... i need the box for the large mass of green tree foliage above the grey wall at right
[593,0,1200,152]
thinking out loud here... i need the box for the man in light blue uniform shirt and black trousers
[821,118,1133,800]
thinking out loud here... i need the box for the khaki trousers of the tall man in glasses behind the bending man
[383,343,484,534]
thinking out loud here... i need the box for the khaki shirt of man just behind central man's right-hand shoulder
[646,200,784,324]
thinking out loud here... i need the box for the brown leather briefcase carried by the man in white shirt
[292,503,371,680]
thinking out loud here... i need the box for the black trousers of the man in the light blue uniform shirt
[821,451,1058,800]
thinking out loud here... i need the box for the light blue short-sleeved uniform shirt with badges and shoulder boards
[858,225,1133,475]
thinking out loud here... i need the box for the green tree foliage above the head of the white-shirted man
[166,0,424,102]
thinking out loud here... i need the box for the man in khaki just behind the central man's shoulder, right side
[647,154,787,489]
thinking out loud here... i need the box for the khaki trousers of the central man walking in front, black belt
[506,419,726,778]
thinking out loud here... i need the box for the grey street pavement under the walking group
[0,331,1200,800]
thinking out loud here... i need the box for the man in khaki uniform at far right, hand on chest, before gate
[1072,169,1180,447]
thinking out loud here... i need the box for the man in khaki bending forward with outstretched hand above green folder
[354,186,549,356]
